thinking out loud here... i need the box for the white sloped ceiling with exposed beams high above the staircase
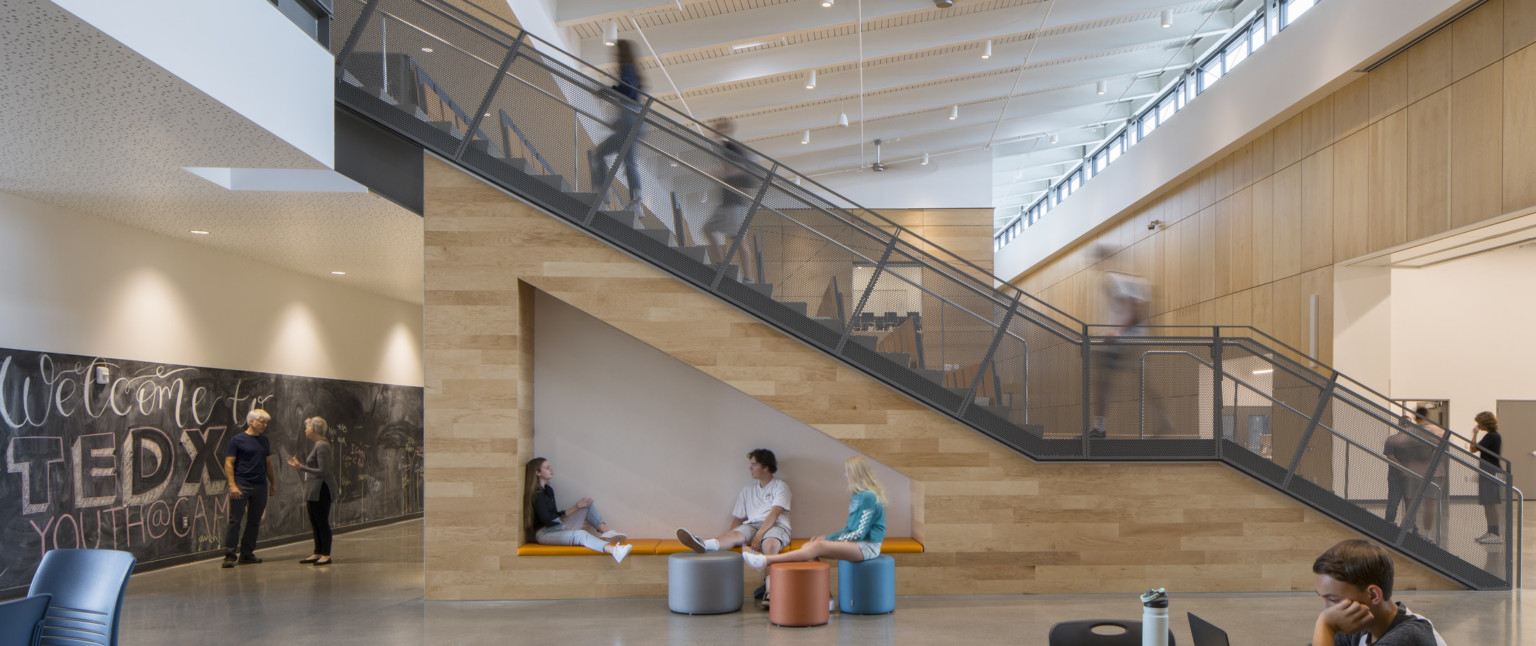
[553,0,1261,224]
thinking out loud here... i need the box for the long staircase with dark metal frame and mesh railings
[333,0,1518,589]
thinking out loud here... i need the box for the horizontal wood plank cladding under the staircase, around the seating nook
[424,158,1455,600]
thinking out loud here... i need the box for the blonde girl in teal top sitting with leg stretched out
[742,456,886,572]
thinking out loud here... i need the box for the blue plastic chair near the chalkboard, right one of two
[28,549,138,646]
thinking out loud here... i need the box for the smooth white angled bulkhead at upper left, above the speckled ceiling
[54,0,334,167]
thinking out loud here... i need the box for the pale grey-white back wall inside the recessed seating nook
[533,293,912,539]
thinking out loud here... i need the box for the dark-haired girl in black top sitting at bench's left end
[522,457,634,563]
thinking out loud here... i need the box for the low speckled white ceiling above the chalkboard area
[0,0,422,304]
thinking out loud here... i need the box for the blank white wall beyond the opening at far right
[1390,247,1536,436]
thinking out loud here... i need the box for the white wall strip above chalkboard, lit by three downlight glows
[0,188,422,385]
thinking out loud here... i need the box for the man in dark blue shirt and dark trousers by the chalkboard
[224,408,278,568]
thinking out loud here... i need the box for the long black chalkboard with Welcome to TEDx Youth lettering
[0,348,422,591]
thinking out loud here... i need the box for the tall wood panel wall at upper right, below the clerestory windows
[1011,0,1536,369]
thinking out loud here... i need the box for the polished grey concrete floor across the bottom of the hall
[121,509,1536,646]
